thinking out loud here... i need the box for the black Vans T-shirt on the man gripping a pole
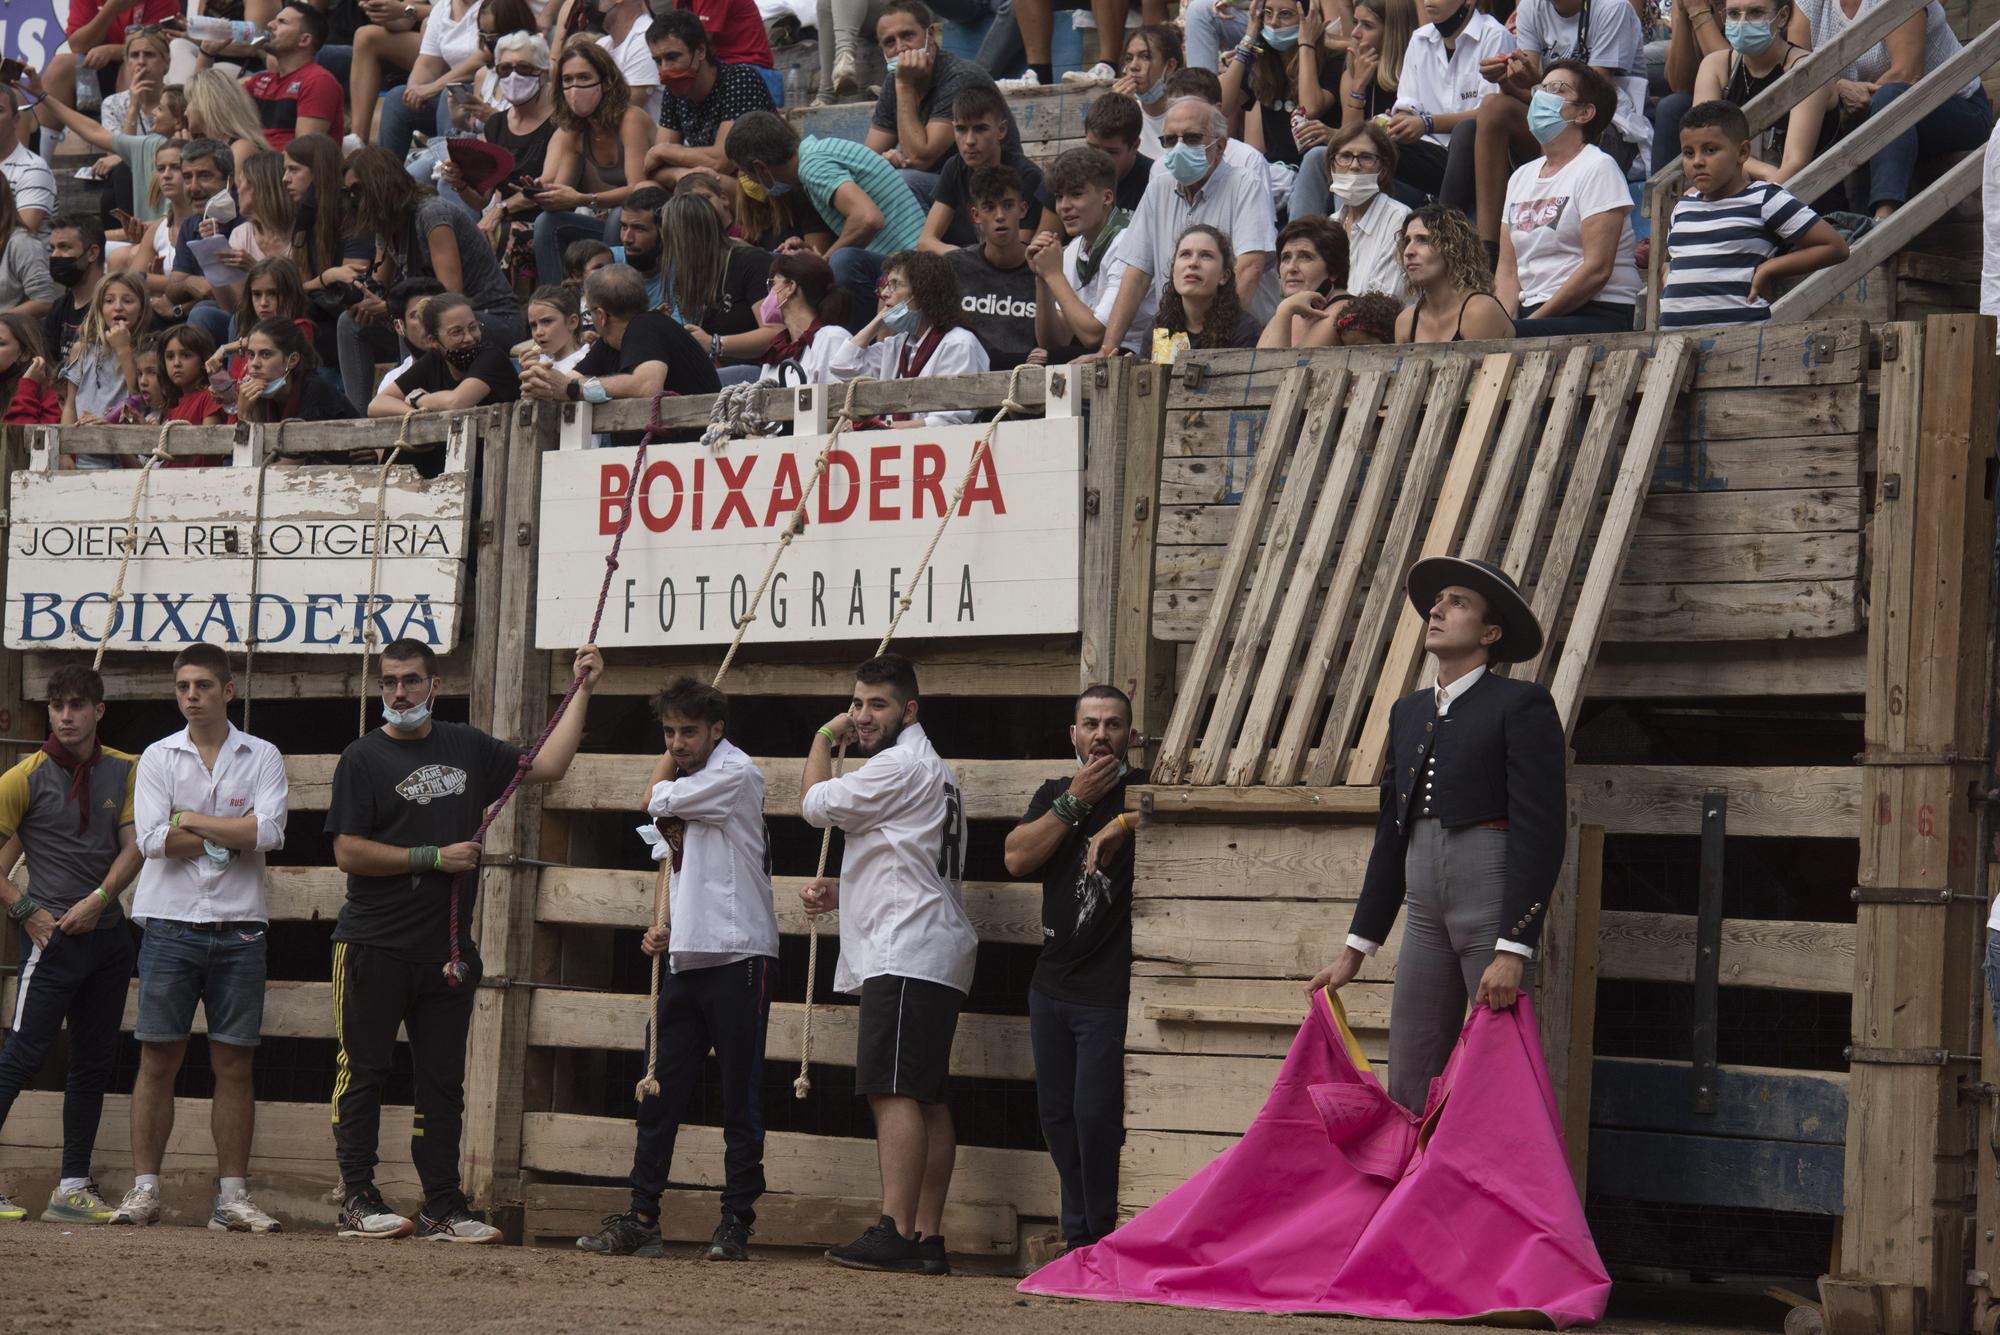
[326,719,522,963]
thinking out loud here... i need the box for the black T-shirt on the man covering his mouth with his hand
[1020,769,1150,1007]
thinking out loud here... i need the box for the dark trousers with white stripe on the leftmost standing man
[0,927,138,1177]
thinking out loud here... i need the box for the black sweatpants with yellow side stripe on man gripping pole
[334,941,480,1219]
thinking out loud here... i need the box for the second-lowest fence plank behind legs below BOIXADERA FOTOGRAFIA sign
[524,1095,1060,1219]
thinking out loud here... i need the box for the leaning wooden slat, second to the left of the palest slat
[1264,360,1432,783]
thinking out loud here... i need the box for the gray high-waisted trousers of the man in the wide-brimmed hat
[1388,817,1534,1113]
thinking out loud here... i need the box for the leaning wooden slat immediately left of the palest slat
[1304,356,1472,783]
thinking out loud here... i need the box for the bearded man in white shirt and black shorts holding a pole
[798,654,978,1275]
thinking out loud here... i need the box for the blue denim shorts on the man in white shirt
[132,917,264,1047]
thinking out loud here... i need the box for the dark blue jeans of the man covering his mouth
[1028,987,1126,1247]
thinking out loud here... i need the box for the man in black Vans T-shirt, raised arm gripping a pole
[326,640,604,1243]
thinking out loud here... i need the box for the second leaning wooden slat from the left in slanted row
[1190,370,1348,783]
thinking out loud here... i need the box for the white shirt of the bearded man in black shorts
[798,723,980,991]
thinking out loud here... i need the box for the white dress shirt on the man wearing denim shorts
[132,723,290,927]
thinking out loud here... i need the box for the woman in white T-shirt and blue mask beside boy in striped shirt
[1494,60,1640,334]
